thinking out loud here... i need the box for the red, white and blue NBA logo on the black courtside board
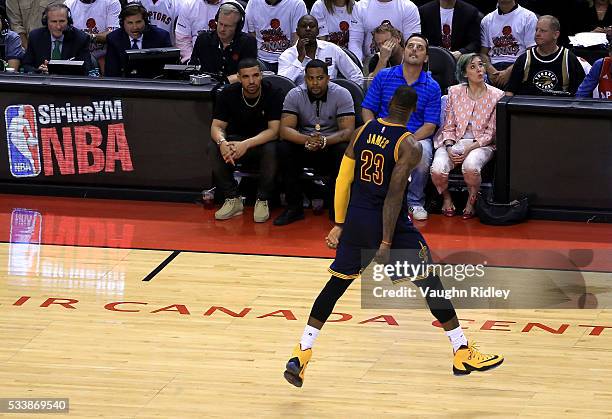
[4,105,41,177]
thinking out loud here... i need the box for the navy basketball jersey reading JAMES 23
[349,118,410,213]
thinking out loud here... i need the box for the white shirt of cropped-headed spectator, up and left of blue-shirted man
[349,0,421,62]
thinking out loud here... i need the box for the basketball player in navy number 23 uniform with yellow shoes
[284,86,504,387]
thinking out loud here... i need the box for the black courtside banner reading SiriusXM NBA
[0,94,211,190]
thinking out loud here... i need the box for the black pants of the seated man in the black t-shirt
[208,138,278,201]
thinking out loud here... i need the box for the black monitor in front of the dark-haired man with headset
[125,47,181,79]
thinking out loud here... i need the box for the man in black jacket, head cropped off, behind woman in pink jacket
[419,0,480,58]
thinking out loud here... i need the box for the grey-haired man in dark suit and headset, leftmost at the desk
[22,4,92,74]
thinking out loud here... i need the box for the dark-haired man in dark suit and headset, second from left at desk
[104,3,172,78]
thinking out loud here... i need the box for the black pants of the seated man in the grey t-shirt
[278,141,348,210]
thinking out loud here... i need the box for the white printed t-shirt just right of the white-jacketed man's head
[310,0,358,48]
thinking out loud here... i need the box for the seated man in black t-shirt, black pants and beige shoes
[209,58,283,223]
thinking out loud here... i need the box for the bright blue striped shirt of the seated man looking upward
[361,64,442,132]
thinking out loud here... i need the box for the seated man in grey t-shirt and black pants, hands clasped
[274,59,355,226]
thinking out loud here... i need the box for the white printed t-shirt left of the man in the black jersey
[480,6,538,64]
